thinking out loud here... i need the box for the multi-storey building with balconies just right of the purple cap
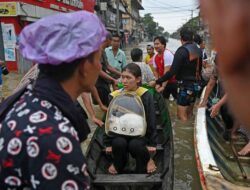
[96,0,144,46]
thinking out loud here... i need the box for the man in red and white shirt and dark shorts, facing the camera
[153,36,177,98]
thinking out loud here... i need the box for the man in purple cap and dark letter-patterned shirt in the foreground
[0,11,107,190]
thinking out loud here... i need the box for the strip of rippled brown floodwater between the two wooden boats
[169,102,201,190]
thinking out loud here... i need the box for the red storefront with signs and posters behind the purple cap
[0,0,95,72]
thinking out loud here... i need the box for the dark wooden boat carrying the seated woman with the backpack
[86,89,174,190]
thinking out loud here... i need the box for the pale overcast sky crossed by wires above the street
[140,0,198,33]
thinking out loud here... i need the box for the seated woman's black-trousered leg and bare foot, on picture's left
[108,137,128,174]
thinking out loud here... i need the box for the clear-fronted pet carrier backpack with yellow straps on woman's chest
[105,87,147,137]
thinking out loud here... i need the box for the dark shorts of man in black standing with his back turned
[177,84,196,106]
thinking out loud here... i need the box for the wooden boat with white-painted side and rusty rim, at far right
[194,89,250,190]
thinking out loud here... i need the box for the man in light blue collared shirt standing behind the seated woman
[105,35,127,78]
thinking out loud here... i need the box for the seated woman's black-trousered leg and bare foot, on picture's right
[128,138,156,174]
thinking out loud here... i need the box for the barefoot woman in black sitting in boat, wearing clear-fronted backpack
[104,63,156,174]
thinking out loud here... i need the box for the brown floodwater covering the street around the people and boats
[3,39,201,190]
